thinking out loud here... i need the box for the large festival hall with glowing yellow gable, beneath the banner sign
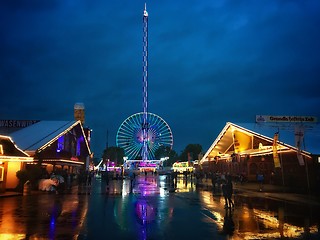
[199,117,320,189]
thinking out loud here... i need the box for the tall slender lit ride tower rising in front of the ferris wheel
[141,3,149,161]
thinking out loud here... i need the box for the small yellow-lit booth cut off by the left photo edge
[0,135,33,192]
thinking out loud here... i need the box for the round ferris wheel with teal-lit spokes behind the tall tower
[116,112,173,160]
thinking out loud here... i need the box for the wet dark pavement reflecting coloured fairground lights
[0,175,320,240]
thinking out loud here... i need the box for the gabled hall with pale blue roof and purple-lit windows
[10,121,91,173]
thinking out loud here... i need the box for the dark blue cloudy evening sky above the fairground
[0,0,320,156]
